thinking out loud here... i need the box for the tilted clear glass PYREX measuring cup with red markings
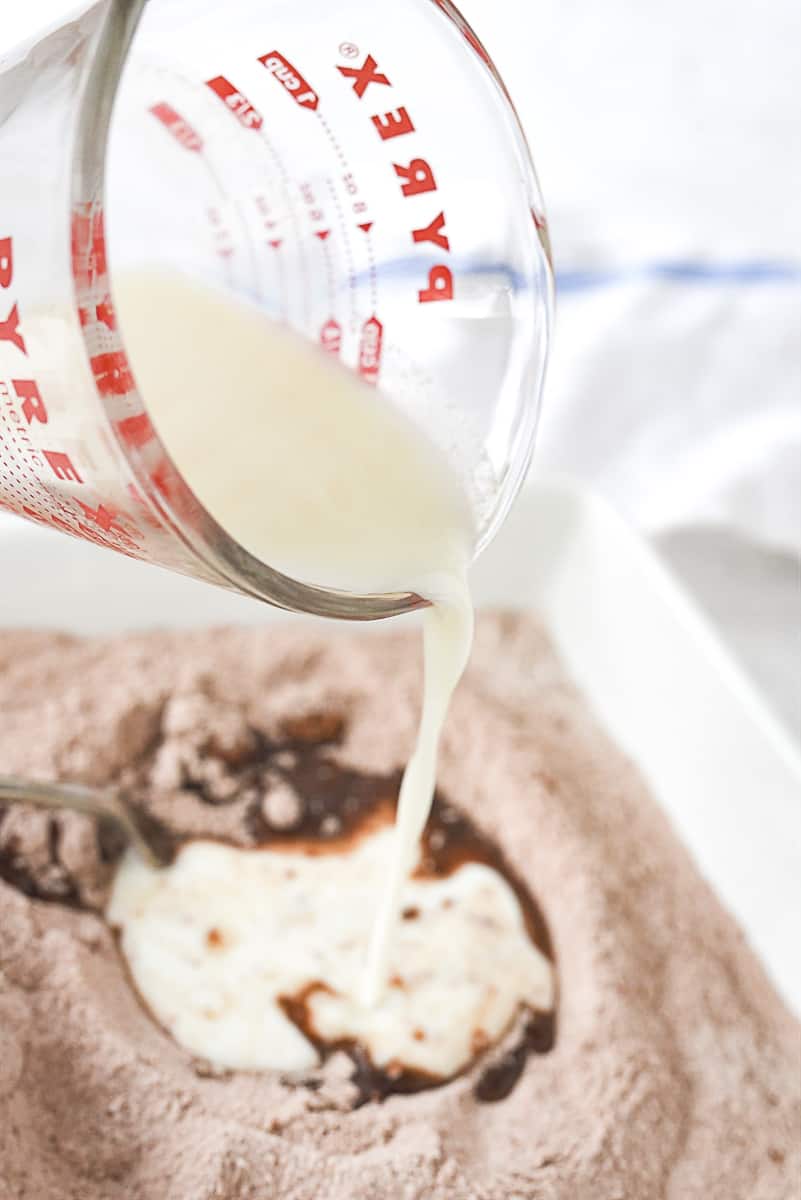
[0,0,552,618]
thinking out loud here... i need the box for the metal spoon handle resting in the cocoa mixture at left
[0,775,175,866]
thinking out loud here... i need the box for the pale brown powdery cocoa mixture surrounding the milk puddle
[0,614,801,1200]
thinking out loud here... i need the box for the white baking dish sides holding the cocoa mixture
[0,480,801,1013]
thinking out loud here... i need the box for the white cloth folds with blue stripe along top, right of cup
[537,264,801,551]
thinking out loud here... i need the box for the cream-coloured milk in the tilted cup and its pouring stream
[114,269,474,1006]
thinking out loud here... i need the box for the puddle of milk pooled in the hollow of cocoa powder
[107,827,554,1079]
